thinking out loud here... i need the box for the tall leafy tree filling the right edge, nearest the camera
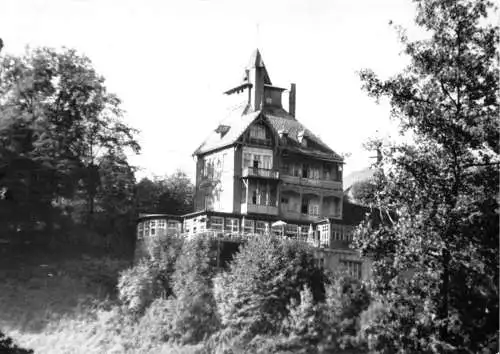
[356,0,500,353]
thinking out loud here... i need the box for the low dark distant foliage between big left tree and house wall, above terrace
[137,171,194,215]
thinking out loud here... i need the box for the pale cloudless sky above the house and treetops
[0,0,418,178]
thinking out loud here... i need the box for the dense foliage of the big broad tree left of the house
[0,48,139,249]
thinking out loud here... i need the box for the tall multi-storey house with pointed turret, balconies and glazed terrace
[138,50,370,278]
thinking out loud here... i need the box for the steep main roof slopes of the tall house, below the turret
[194,104,343,162]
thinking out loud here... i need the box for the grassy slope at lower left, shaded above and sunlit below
[0,252,203,354]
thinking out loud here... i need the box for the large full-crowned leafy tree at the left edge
[0,48,139,234]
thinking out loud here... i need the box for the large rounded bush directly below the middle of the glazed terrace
[214,237,323,338]
